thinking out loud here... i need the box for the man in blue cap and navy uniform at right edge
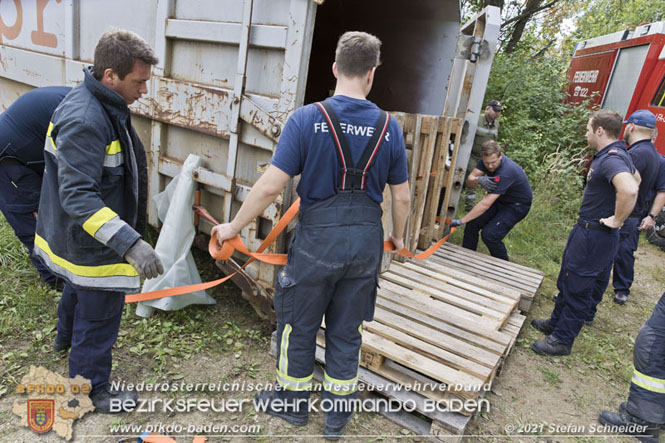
[608,109,660,310]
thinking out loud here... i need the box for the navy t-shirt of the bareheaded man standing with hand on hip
[579,141,635,221]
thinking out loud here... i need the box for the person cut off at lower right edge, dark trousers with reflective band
[598,294,665,443]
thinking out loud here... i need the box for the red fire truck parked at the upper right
[567,21,665,249]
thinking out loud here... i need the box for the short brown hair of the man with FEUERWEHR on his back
[335,31,381,77]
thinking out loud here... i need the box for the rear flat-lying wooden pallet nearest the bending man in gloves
[429,243,544,313]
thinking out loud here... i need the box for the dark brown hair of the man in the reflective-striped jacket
[92,29,159,80]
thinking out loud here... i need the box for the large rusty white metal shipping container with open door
[0,0,500,317]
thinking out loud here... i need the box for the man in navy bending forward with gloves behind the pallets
[451,140,533,260]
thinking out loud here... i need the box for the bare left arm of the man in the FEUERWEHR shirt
[210,165,291,244]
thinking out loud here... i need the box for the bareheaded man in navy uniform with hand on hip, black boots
[531,110,639,355]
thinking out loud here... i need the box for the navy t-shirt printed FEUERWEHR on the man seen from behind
[270,95,409,207]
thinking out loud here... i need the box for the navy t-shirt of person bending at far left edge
[0,86,72,173]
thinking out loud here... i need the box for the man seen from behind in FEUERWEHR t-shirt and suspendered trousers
[212,32,410,439]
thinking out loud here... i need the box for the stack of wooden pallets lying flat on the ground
[273,246,543,441]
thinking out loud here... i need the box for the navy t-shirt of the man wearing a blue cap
[628,139,661,217]
